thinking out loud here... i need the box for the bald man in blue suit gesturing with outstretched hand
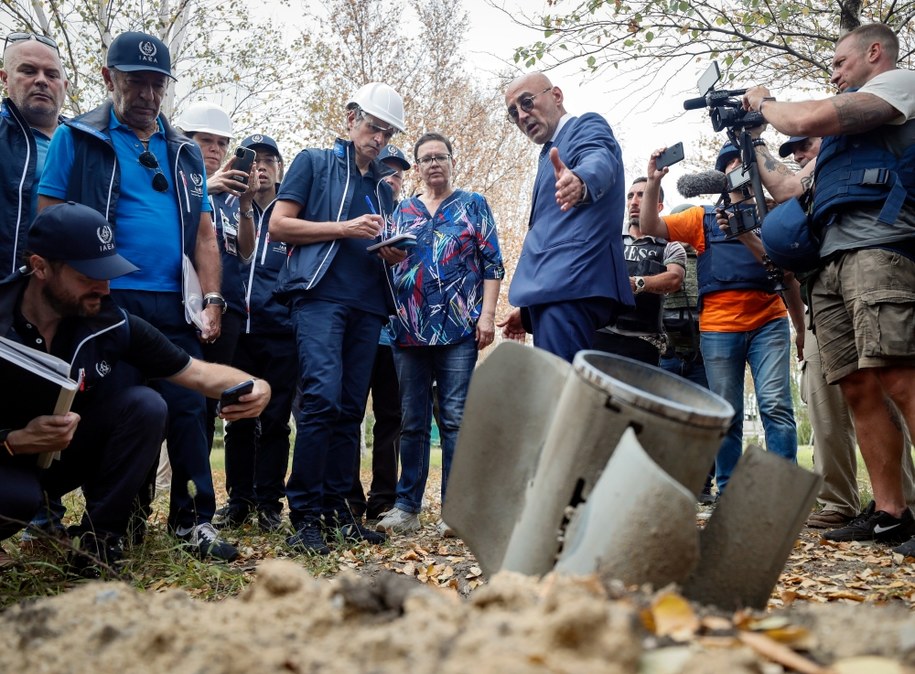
[499,73,634,361]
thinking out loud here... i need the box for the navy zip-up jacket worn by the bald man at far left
[0,98,64,278]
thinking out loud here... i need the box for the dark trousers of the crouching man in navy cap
[0,386,168,539]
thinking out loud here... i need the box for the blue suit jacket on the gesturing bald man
[508,113,635,307]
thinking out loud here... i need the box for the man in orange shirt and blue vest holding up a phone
[639,142,797,493]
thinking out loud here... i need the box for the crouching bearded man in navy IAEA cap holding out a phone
[0,202,270,570]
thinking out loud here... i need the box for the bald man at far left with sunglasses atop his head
[0,33,68,278]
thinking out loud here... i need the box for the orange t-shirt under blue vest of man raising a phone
[663,206,788,332]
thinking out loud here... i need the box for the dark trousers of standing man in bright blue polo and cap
[111,290,216,529]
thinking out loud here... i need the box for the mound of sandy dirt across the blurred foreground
[0,560,915,674]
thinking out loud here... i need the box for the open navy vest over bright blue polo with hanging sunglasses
[60,101,206,262]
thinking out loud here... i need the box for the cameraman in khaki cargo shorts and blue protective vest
[743,24,915,556]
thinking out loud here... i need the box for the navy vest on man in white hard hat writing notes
[275,138,394,306]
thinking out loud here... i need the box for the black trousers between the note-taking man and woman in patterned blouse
[346,344,401,516]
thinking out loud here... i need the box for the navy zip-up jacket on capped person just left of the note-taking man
[245,196,292,337]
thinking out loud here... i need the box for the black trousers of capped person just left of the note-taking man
[225,333,298,513]
